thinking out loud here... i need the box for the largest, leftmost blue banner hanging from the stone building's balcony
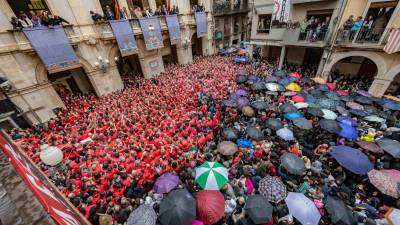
[23,26,80,73]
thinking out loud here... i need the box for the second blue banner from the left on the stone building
[110,20,138,56]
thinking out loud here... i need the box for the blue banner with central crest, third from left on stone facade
[139,17,164,50]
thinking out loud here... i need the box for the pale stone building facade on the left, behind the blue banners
[0,0,214,127]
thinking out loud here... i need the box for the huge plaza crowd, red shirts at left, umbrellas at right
[10,56,400,225]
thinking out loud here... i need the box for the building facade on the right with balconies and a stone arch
[251,0,400,96]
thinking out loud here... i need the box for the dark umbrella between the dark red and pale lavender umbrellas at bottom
[244,195,273,224]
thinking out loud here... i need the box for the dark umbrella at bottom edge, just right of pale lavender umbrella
[325,195,357,225]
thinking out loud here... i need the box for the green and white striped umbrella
[196,162,228,190]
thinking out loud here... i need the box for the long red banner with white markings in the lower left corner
[0,132,89,225]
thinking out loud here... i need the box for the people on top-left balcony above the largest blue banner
[11,11,69,29]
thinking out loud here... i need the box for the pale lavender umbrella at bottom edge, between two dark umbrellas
[285,192,321,225]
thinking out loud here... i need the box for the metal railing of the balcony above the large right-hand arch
[337,27,385,44]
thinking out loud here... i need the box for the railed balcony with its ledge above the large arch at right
[336,27,385,48]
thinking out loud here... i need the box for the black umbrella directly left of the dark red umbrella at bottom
[159,189,196,225]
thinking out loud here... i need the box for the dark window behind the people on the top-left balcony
[7,0,49,16]
